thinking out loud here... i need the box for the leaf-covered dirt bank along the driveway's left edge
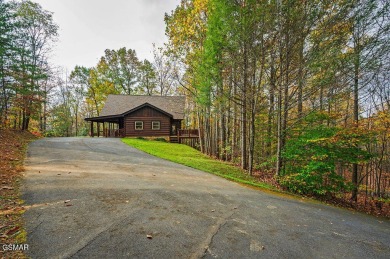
[0,129,37,258]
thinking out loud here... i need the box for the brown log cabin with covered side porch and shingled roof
[85,95,198,142]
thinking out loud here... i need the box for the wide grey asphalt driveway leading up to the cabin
[23,138,390,258]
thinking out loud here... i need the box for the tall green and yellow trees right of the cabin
[165,0,390,213]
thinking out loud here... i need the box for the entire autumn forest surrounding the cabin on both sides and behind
[0,0,390,207]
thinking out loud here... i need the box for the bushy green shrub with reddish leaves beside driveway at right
[279,114,370,196]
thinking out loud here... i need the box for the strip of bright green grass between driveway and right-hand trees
[122,138,275,190]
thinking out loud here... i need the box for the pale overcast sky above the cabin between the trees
[32,0,180,71]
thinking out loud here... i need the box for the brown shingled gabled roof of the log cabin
[99,94,185,120]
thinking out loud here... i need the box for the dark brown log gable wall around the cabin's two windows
[125,107,171,137]
